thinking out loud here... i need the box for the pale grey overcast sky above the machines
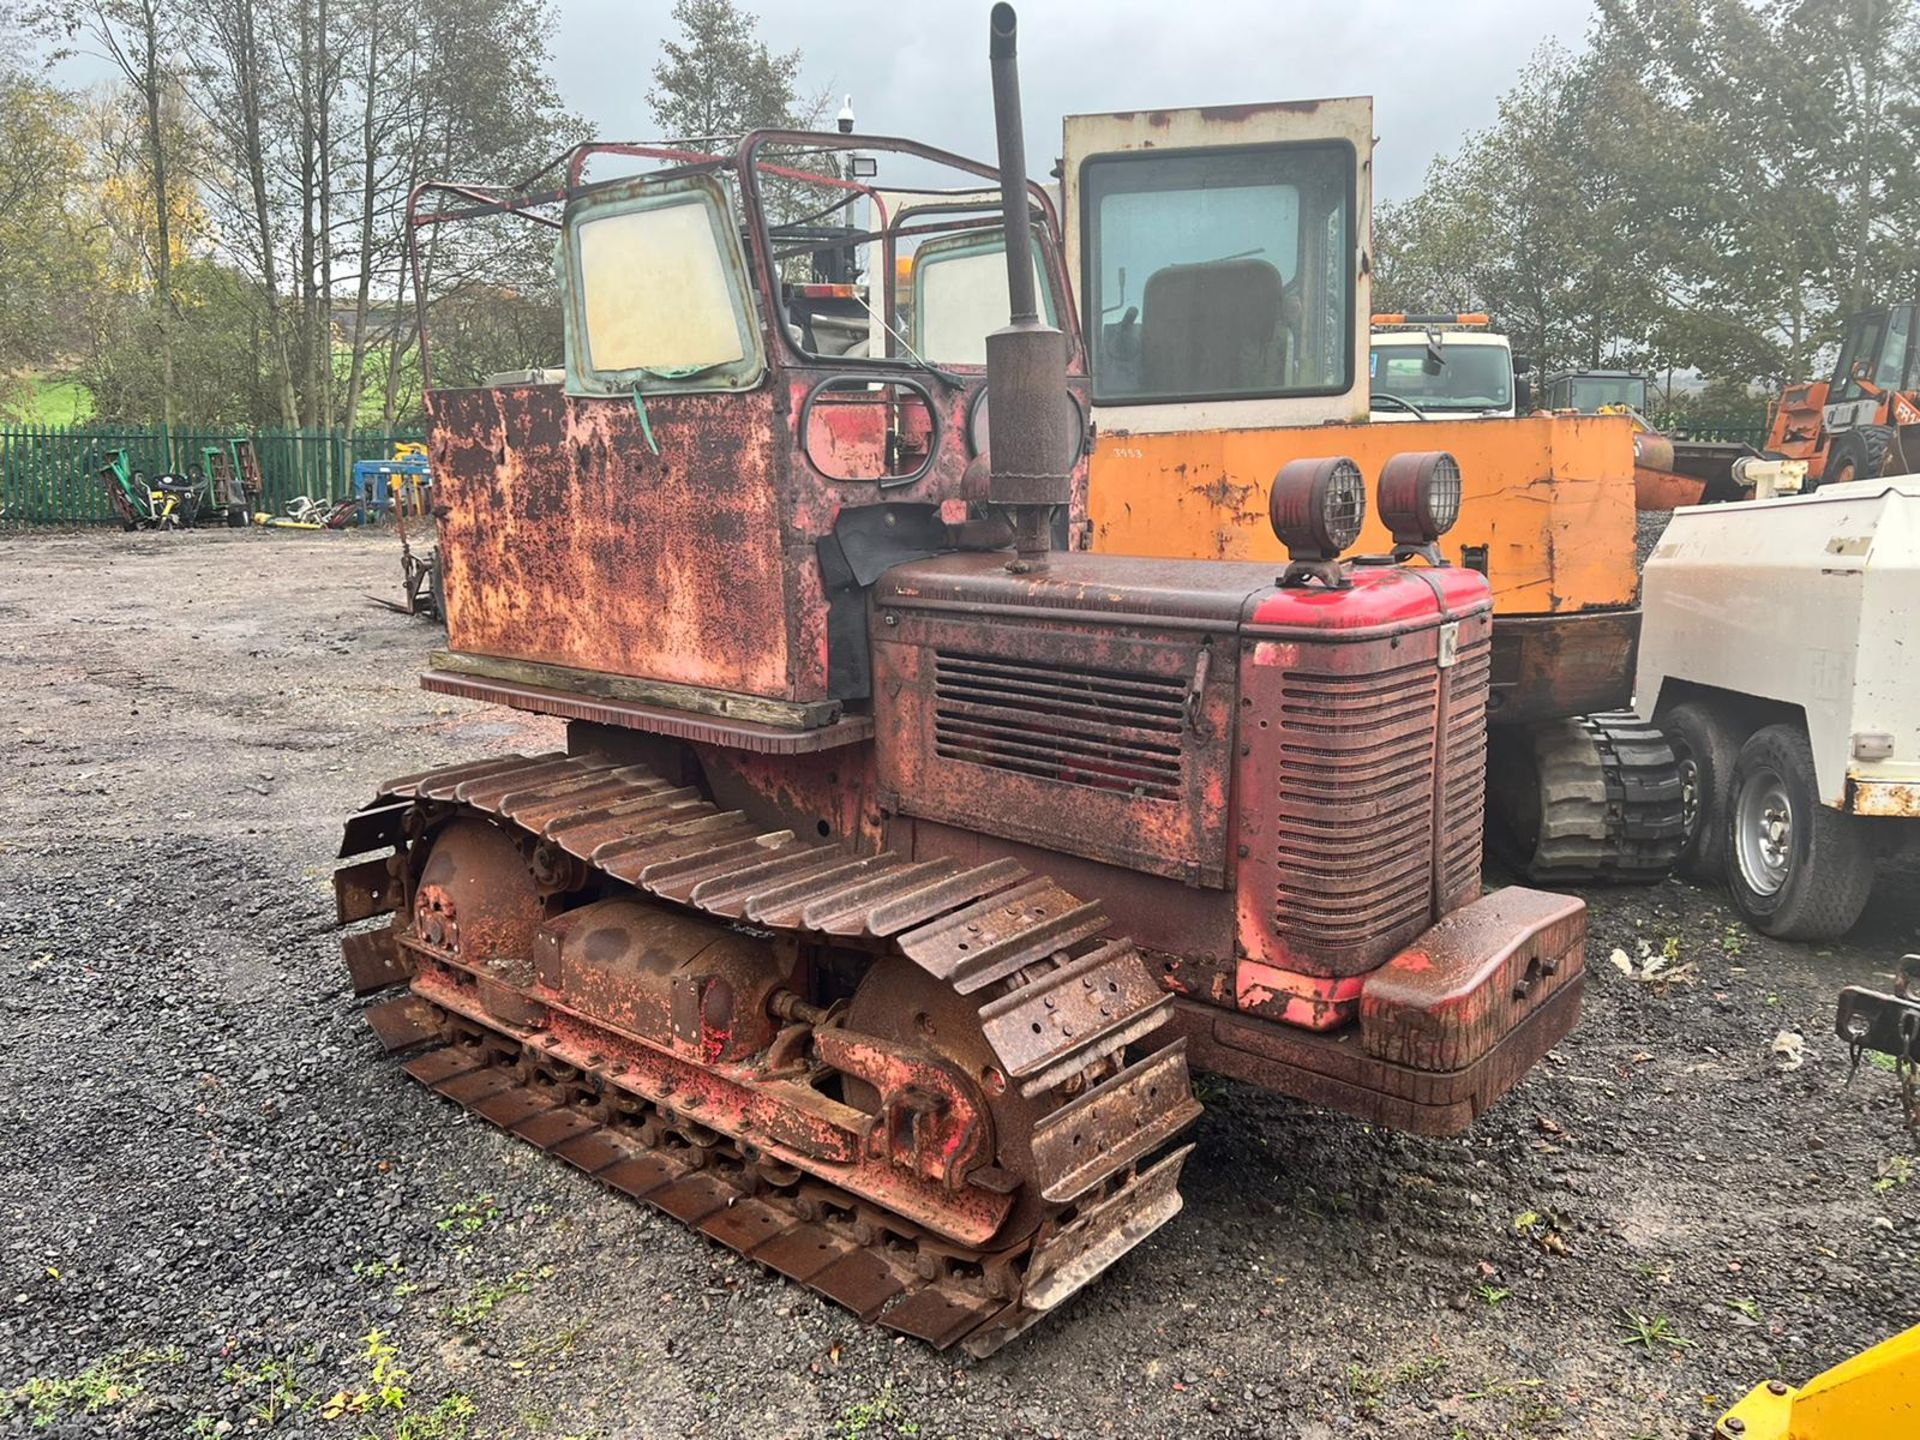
[553,0,1592,200]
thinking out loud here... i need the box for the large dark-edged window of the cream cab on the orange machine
[1081,144,1354,403]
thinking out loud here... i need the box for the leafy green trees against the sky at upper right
[1377,0,1920,394]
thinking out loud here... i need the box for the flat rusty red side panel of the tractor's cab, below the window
[434,386,806,699]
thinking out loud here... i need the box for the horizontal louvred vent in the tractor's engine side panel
[933,651,1187,801]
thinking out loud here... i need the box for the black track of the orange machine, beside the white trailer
[1496,710,1686,885]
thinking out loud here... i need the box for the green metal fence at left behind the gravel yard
[0,424,424,524]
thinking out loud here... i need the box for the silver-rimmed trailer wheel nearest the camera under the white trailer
[1722,726,1874,941]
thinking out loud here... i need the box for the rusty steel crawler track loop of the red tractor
[334,755,1200,1356]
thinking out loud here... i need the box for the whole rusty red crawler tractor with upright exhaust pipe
[336,6,1586,1354]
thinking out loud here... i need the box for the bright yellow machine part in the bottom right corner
[1713,1325,1920,1440]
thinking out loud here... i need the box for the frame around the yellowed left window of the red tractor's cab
[561,175,766,399]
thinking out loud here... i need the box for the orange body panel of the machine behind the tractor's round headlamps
[1089,415,1640,614]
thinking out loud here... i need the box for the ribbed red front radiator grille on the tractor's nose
[1273,639,1490,948]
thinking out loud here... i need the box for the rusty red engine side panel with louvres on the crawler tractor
[874,555,1244,887]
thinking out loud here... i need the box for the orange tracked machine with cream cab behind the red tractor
[1062,98,1680,883]
